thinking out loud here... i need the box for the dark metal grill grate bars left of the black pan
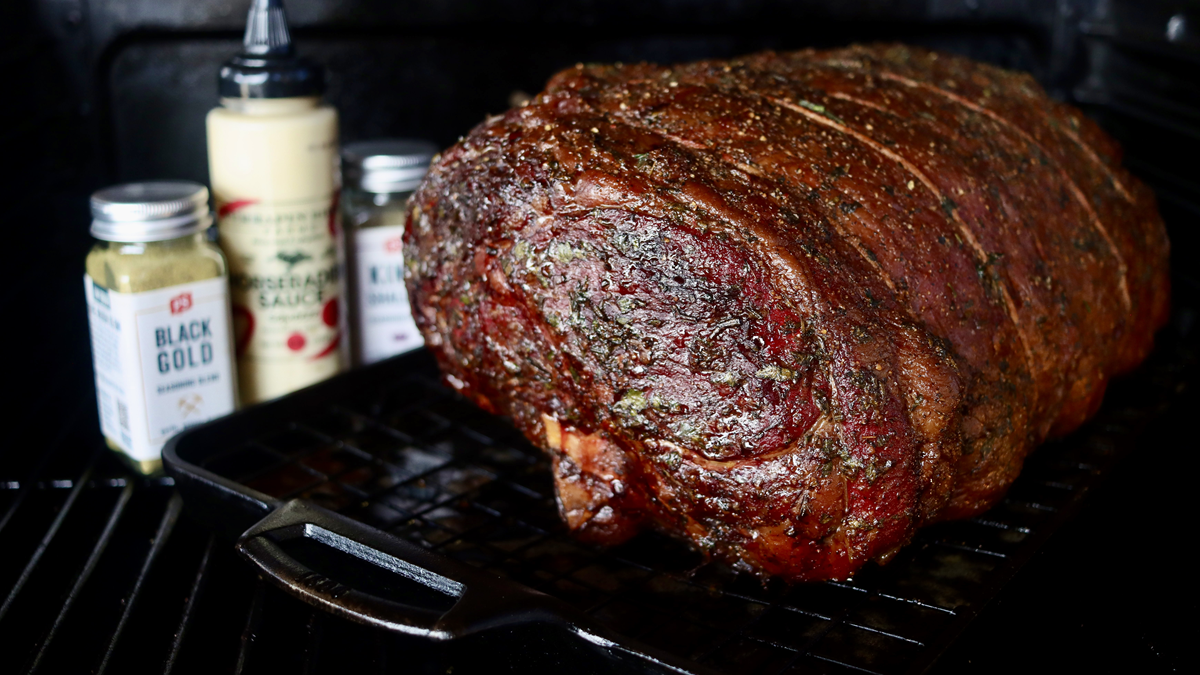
[0,437,444,675]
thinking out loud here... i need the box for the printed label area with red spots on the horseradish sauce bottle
[218,197,342,402]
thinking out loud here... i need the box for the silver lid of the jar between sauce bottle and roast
[342,138,438,193]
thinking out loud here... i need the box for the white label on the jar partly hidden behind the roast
[354,225,425,363]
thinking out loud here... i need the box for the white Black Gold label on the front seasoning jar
[84,275,236,461]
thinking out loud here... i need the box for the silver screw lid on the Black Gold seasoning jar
[91,180,212,241]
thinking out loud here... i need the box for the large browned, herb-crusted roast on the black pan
[404,44,1169,581]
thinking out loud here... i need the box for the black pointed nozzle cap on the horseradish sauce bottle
[217,0,325,98]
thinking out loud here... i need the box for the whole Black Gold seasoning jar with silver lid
[84,181,238,473]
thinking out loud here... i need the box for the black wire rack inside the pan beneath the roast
[182,329,1180,674]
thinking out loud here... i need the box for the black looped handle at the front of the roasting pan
[236,500,578,640]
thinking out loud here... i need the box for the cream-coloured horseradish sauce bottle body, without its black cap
[208,97,343,404]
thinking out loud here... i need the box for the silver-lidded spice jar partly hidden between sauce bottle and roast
[342,139,437,364]
